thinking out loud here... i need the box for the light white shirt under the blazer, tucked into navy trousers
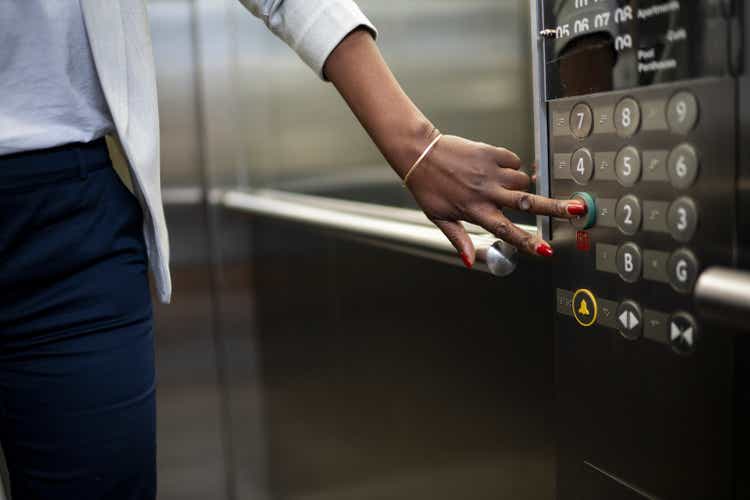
[0,0,114,156]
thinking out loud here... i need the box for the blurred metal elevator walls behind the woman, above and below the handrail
[149,0,554,500]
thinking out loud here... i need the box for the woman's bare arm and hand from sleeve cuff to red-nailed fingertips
[324,30,586,267]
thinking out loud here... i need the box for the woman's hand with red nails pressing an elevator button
[408,131,586,267]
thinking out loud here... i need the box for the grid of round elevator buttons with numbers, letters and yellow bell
[548,78,736,354]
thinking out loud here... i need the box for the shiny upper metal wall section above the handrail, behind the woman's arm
[232,0,533,203]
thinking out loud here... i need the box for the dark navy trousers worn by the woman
[0,140,156,500]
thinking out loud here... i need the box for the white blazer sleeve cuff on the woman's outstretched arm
[240,0,377,78]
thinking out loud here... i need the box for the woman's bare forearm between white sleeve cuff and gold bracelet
[324,29,436,178]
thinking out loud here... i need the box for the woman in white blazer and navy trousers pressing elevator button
[0,0,585,500]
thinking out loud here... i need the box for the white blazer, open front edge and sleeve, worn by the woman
[76,0,375,302]
